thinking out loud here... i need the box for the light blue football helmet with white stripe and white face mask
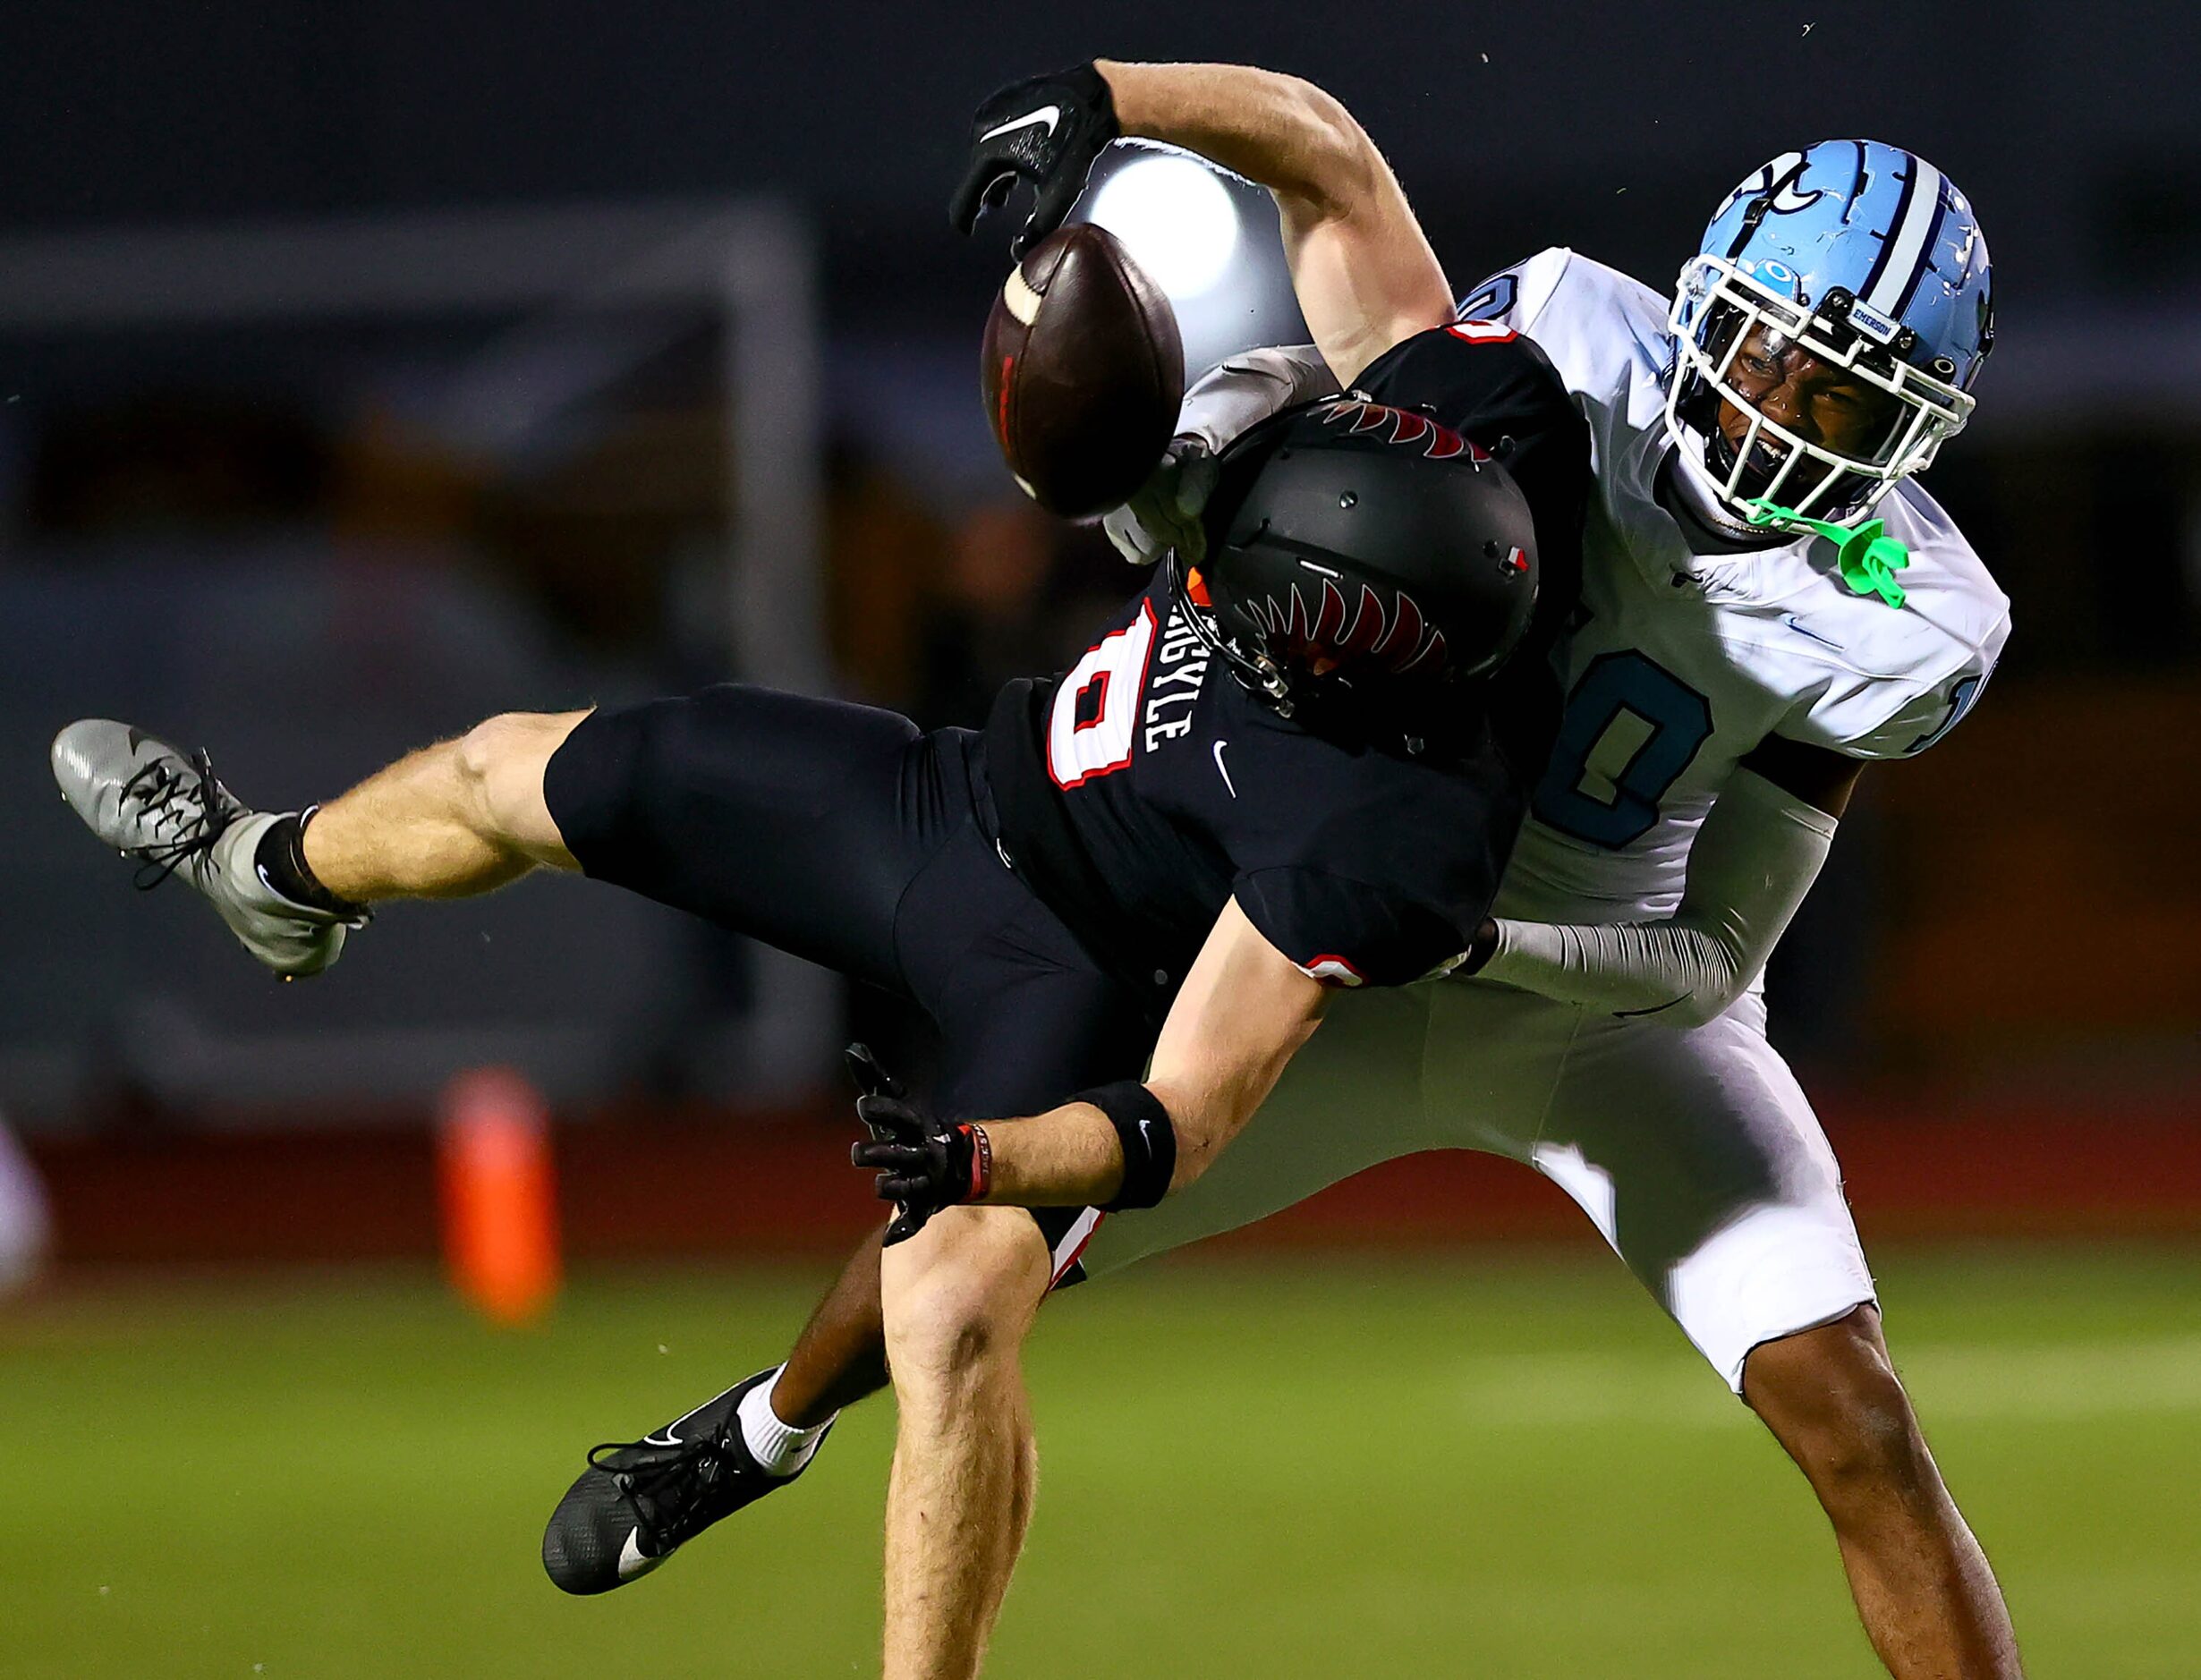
[1666,141,1994,530]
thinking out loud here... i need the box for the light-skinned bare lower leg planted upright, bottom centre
[880,1207,1052,1680]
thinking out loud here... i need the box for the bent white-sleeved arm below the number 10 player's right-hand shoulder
[1464,738,1862,1026]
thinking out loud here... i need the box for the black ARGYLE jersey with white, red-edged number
[986,324,1589,988]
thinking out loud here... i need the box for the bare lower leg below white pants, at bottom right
[1743,1306,2020,1680]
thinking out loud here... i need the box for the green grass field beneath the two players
[0,1249,2201,1680]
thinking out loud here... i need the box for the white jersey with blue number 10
[1459,249,2010,922]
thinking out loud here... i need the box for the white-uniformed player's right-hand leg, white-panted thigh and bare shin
[1517,999,2018,1678]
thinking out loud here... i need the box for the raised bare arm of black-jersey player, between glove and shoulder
[1094,59,1453,386]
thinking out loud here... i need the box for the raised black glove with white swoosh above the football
[948,64,1123,258]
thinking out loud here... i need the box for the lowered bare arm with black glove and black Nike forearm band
[852,903,1327,1244]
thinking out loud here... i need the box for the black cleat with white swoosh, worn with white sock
[544,1365,829,1594]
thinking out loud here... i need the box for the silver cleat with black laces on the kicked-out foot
[53,717,363,980]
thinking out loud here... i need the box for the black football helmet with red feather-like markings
[1171,396,1541,735]
